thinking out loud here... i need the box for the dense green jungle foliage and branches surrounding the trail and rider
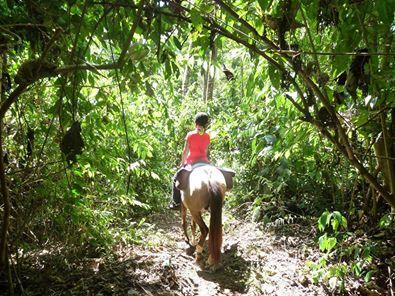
[0,0,395,291]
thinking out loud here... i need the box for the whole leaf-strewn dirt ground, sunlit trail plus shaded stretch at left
[11,210,328,296]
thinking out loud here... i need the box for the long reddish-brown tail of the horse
[208,182,223,264]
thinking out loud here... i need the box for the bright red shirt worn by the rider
[185,130,210,164]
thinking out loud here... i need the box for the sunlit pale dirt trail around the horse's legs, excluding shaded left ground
[113,211,327,295]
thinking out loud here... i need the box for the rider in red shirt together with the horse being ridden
[172,113,235,270]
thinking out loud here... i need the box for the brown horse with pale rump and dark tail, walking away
[175,163,235,270]
